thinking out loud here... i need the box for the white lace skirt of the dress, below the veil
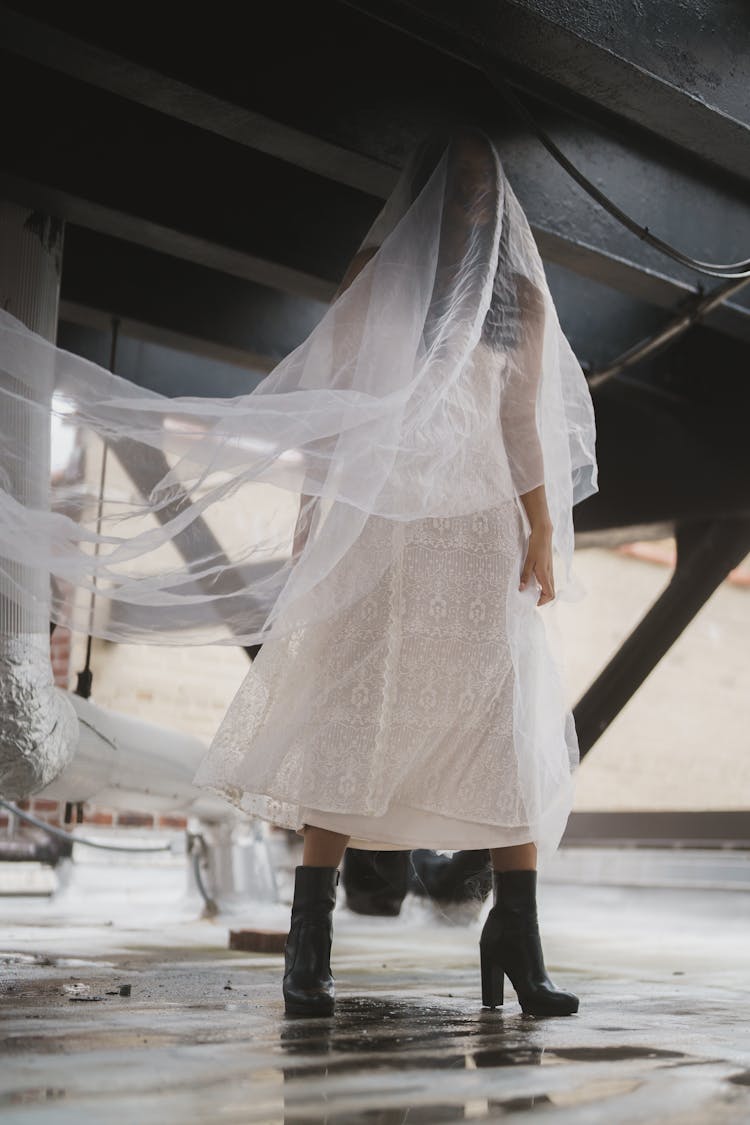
[195,492,571,849]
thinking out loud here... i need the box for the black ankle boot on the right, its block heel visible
[479,870,578,1016]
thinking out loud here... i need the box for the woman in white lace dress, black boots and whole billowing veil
[0,126,597,1015]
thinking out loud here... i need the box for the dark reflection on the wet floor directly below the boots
[280,998,686,1125]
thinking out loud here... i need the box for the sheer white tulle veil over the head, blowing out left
[0,120,597,645]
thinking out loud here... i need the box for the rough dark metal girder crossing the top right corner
[345,0,750,179]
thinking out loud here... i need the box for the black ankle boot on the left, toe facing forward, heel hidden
[283,866,338,1016]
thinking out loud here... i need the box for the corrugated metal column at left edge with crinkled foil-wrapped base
[0,200,78,799]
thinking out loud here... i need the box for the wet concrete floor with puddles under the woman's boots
[0,884,750,1125]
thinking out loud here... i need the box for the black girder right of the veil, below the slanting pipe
[573,327,750,534]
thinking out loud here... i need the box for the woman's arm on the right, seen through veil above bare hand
[500,273,545,496]
